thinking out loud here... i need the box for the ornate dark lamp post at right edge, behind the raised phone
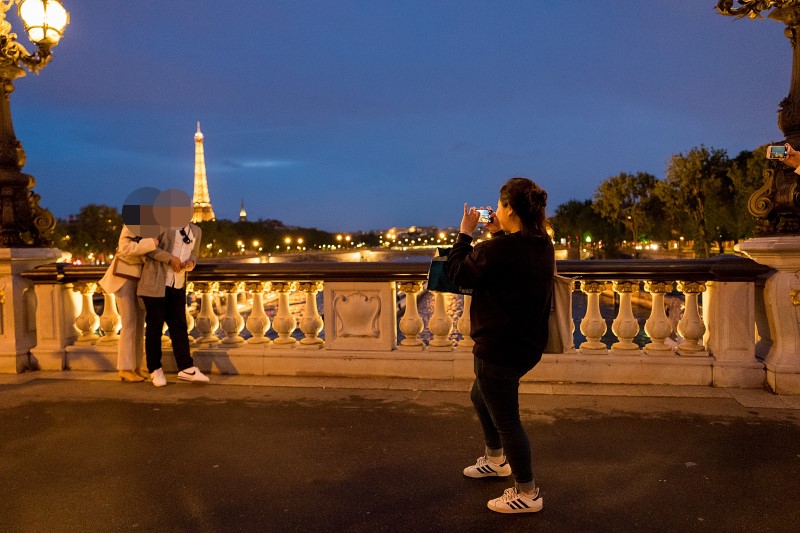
[717,0,800,235]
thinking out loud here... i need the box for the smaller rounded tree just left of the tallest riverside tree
[592,172,660,242]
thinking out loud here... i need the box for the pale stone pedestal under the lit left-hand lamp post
[0,248,61,373]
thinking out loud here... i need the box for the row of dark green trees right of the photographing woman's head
[550,145,780,257]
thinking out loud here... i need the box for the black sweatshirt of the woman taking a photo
[445,232,555,372]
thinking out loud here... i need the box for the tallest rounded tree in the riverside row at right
[657,146,734,257]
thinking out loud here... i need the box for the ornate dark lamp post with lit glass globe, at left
[0,0,69,248]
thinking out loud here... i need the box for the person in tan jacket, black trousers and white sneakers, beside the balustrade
[138,223,208,387]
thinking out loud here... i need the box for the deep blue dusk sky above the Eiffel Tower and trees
[9,0,792,231]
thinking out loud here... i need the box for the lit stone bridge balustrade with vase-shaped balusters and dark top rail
[17,256,788,387]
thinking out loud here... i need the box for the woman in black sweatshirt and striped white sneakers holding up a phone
[446,178,555,513]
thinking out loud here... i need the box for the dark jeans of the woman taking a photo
[470,357,533,484]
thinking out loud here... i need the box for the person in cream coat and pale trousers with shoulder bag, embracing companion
[100,226,158,381]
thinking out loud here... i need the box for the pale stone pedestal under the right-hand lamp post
[737,236,800,394]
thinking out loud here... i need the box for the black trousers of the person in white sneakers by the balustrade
[142,287,194,373]
